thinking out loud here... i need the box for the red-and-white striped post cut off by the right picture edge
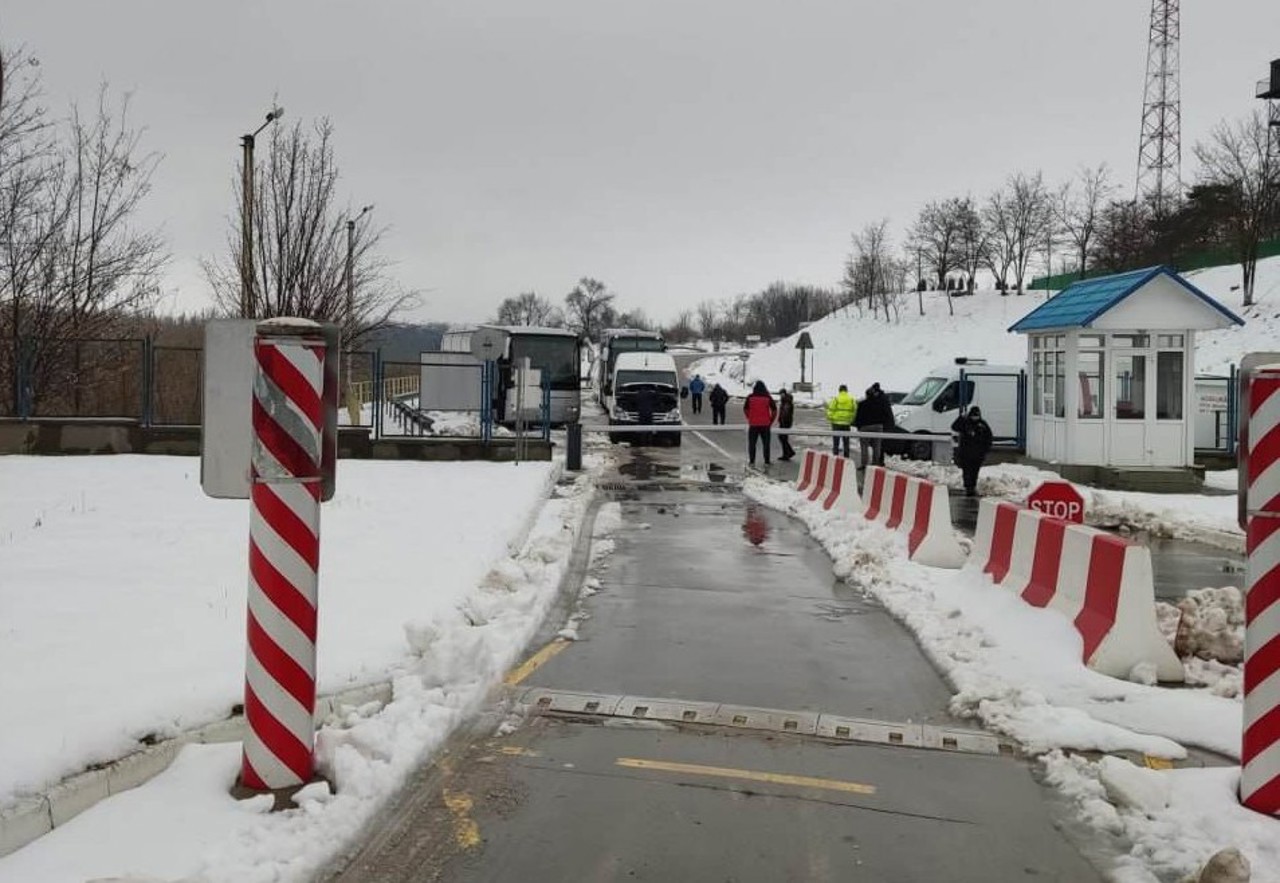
[1240,365,1280,815]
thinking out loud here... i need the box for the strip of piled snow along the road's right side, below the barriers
[745,477,1280,883]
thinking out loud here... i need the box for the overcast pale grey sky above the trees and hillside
[0,0,1280,321]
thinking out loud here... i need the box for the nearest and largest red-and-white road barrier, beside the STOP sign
[972,499,1183,681]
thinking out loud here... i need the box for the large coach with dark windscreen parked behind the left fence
[440,325,582,424]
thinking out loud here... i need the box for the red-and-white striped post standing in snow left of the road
[239,319,325,791]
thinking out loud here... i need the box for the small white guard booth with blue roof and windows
[1009,266,1244,468]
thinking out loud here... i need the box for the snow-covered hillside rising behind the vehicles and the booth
[690,250,1280,398]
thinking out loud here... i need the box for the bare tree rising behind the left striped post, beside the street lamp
[204,119,417,347]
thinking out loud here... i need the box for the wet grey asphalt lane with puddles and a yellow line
[325,401,1098,883]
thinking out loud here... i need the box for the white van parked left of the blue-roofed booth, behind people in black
[893,357,1027,459]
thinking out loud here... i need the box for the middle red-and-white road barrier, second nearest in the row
[863,466,965,568]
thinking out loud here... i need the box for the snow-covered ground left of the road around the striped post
[0,456,609,883]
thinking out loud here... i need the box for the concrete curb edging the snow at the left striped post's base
[0,681,392,856]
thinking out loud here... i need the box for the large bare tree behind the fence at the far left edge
[0,79,168,413]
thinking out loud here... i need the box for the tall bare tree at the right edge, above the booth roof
[1196,111,1280,307]
